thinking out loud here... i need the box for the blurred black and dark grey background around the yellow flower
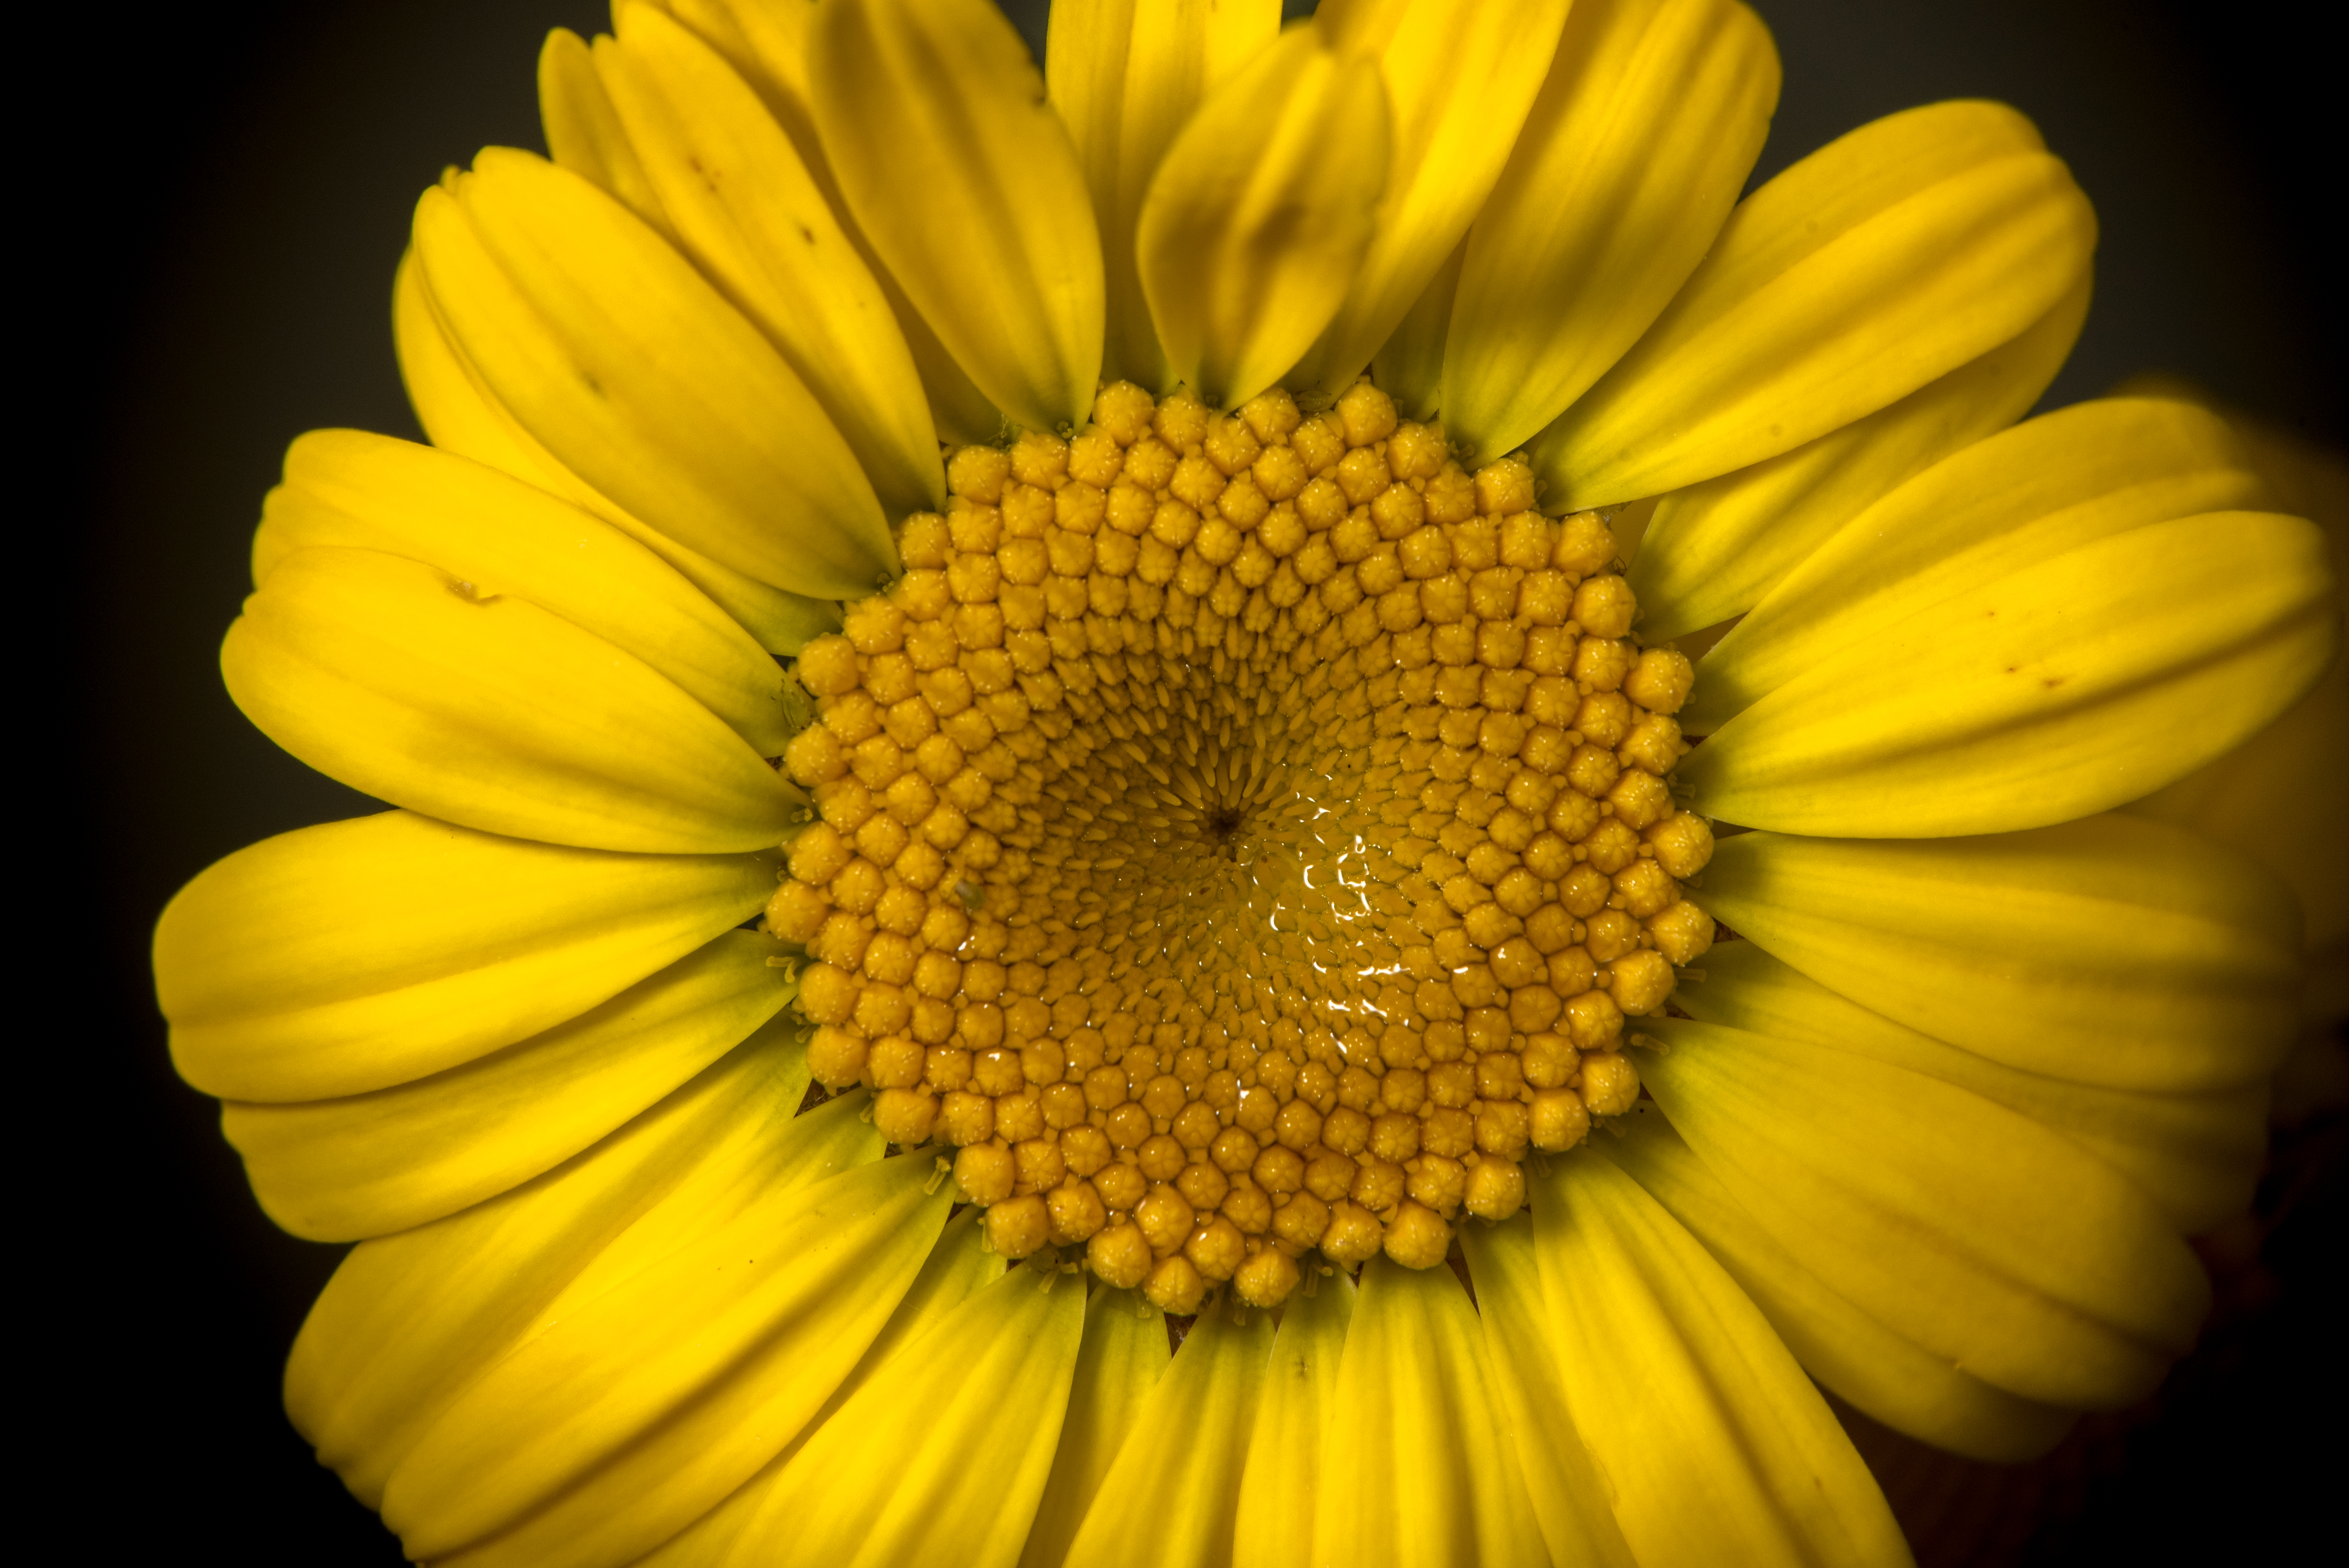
[27,0,2349,1564]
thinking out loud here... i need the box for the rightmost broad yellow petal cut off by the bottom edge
[1531,1150,1910,1568]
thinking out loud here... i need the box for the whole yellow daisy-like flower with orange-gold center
[155,0,2340,1568]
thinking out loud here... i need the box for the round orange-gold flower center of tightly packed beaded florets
[768,380,1712,1312]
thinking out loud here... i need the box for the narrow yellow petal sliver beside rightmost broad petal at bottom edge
[1461,1211,1633,1568]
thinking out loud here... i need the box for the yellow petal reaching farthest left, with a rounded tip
[155,812,778,1101]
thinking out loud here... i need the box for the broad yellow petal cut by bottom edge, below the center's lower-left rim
[686,1267,1085,1568]
